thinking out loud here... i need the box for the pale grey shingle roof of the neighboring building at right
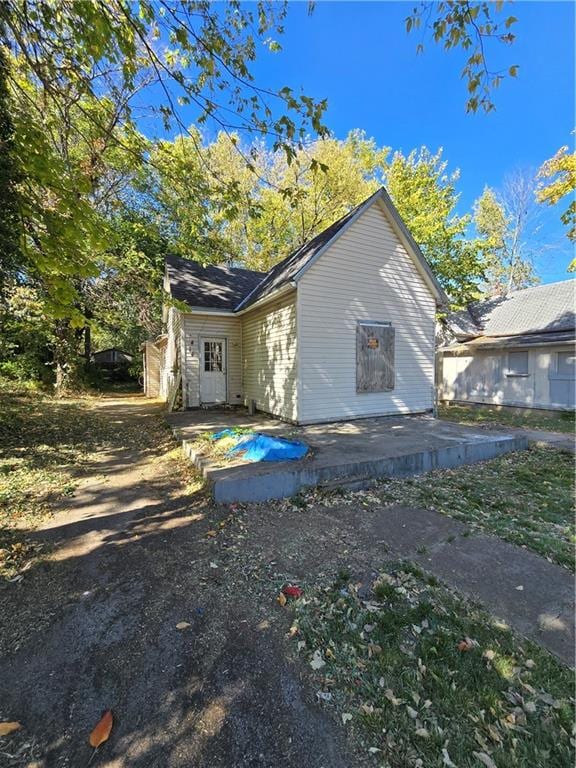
[446,280,576,341]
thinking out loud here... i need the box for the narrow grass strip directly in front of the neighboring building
[438,405,575,433]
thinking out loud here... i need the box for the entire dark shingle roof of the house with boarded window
[166,187,448,312]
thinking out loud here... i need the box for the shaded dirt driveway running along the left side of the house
[0,398,572,768]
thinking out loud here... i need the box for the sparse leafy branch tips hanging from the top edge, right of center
[406,0,518,112]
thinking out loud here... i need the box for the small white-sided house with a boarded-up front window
[146,189,445,424]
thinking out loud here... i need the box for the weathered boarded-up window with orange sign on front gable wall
[356,322,395,392]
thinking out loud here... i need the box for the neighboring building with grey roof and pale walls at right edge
[439,280,576,409]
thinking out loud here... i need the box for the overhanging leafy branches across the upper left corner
[0,0,326,165]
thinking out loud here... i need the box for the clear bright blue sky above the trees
[147,0,576,282]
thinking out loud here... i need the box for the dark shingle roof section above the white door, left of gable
[166,256,265,311]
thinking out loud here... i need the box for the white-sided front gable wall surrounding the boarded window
[298,205,436,423]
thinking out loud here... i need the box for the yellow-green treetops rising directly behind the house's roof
[143,131,484,305]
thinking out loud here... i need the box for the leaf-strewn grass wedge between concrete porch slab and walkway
[375,448,575,570]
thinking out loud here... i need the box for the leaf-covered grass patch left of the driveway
[0,388,178,579]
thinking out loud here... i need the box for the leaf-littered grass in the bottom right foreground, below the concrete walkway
[291,564,574,768]
